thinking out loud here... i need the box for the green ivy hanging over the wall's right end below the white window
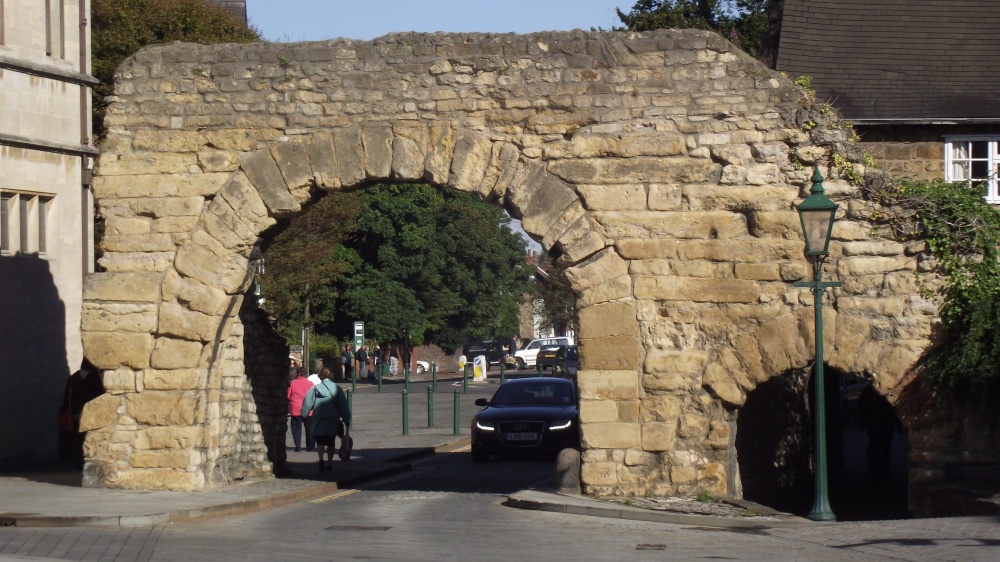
[862,173,1000,404]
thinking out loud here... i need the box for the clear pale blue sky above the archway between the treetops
[247,0,635,42]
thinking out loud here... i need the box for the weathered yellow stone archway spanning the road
[83,30,932,495]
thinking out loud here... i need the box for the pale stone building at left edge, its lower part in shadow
[0,0,97,469]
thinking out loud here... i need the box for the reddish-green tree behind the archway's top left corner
[91,0,260,134]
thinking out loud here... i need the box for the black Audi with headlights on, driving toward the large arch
[472,377,580,462]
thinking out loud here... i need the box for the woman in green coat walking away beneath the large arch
[302,369,351,472]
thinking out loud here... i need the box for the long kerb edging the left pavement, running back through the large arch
[10,436,469,527]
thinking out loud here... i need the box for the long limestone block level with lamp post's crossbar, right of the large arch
[635,277,759,303]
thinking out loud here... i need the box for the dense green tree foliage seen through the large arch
[265,184,530,349]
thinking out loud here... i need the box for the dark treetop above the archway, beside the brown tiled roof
[617,0,776,62]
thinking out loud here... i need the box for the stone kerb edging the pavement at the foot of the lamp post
[504,489,814,529]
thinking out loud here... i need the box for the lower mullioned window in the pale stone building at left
[0,191,53,256]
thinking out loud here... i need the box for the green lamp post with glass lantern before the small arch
[795,167,843,521]
